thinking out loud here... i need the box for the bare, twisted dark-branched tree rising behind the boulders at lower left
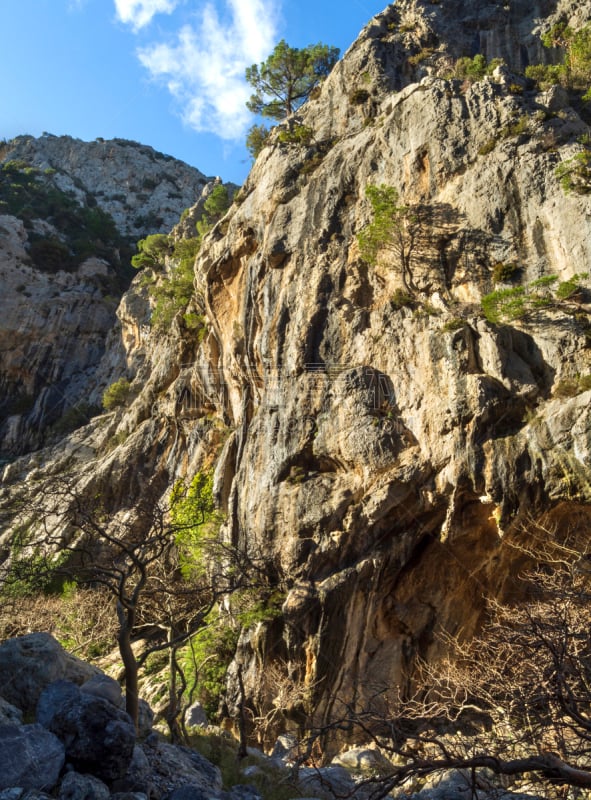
[2,478,262,739]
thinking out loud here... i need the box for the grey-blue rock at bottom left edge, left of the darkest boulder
[0,725,65,792]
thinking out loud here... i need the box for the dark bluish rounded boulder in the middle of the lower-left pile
[37,681,135,781]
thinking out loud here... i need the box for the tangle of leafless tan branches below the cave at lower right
[296,524,591,800]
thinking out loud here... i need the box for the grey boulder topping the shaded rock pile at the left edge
[0,633,99,713]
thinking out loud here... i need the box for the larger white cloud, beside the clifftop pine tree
[138,0,278,140]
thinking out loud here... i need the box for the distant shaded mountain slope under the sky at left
[0,134,222,458]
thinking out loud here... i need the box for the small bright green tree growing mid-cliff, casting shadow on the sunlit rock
[357,184,422,292]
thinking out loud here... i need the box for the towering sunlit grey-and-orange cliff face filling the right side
[5,0,591,752]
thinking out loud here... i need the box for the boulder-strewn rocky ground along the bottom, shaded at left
[0,633,536,800]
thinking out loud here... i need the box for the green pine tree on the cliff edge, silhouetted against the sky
[246,39,339,120]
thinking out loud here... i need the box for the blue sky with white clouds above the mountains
[0,0,387,183]
